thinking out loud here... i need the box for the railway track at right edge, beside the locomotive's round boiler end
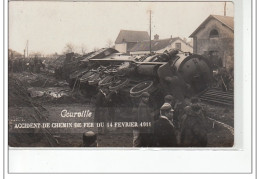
[199,88,234,106]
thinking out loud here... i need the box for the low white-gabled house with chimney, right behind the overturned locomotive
[130,34,193,55]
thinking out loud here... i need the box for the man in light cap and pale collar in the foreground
[153,103,177,147]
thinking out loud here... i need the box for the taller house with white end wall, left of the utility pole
[115,30,150,53]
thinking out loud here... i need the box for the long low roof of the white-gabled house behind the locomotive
[130,37,187,52]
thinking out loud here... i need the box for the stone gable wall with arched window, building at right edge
[193,19,234,68]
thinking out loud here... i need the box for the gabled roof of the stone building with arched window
[189,15,234,37]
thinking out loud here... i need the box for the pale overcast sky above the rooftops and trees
[9,1,234,54]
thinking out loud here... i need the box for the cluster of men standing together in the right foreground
[133,92,210,147]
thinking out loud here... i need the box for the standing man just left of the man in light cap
[133,92,152,147]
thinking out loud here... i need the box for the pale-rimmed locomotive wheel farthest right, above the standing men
[130,81,153,97]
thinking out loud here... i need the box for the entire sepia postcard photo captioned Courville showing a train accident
[8,1,236,148]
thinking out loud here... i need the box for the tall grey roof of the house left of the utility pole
[115,30,150,44]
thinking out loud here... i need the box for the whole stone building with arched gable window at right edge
[190,15,234,69]
